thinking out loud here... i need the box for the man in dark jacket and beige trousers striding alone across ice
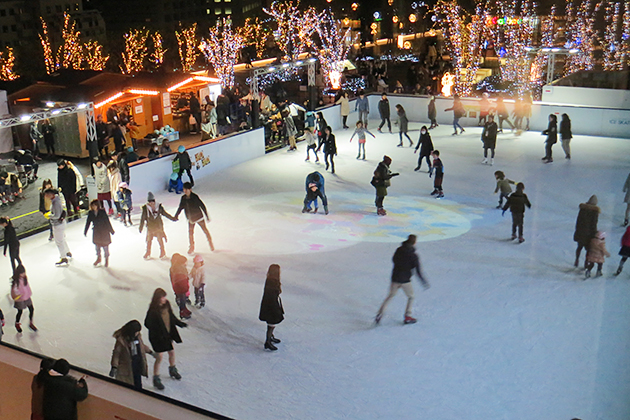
[374,235,429,324]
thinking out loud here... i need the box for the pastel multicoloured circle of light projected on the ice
[231,192,481,254]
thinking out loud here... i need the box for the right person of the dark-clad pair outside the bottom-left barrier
[40,359,88,420]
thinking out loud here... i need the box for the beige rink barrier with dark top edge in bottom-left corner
[0,342,232,420]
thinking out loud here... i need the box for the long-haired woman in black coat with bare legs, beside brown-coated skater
[144,288,188,391]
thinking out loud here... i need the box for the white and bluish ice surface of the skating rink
[0,121,630,420]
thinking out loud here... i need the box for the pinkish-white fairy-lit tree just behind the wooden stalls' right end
[199,19,244,88]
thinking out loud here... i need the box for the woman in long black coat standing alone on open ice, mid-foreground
[258,264,284,351]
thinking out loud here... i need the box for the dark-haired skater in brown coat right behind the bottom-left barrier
[109,319,154,389]
